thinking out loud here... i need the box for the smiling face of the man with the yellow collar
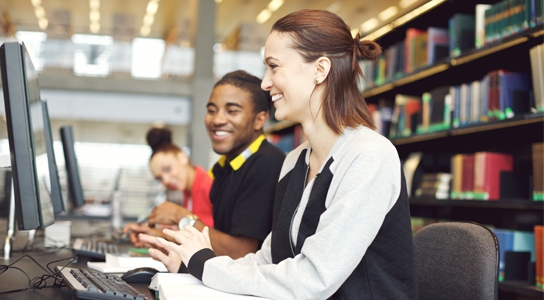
[205,84,266,160]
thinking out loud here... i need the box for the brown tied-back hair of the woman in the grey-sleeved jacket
[271,9,382,134]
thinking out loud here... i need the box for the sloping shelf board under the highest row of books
[362,25,544,99]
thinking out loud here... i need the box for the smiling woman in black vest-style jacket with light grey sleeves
[141,10,418,300]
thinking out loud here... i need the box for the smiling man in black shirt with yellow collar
[133,71,285,260]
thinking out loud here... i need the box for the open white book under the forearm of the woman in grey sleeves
[149,273,267,300]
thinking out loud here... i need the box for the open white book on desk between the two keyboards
[87,253,168,273]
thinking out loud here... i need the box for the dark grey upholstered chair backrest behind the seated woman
[414,222,499,300]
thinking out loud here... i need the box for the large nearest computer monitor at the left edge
[0,42,55,230]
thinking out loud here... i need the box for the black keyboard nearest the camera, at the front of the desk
[57,266,151,300]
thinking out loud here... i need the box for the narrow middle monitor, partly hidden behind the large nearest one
[41,100,65,215]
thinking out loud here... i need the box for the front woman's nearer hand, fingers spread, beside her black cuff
[157,226,212,266]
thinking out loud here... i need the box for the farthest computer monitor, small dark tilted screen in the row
[60,125,85,208]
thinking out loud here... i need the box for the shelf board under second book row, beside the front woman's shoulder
[392,113,544,146]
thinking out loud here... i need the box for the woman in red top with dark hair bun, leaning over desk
[124,127,214,247]
